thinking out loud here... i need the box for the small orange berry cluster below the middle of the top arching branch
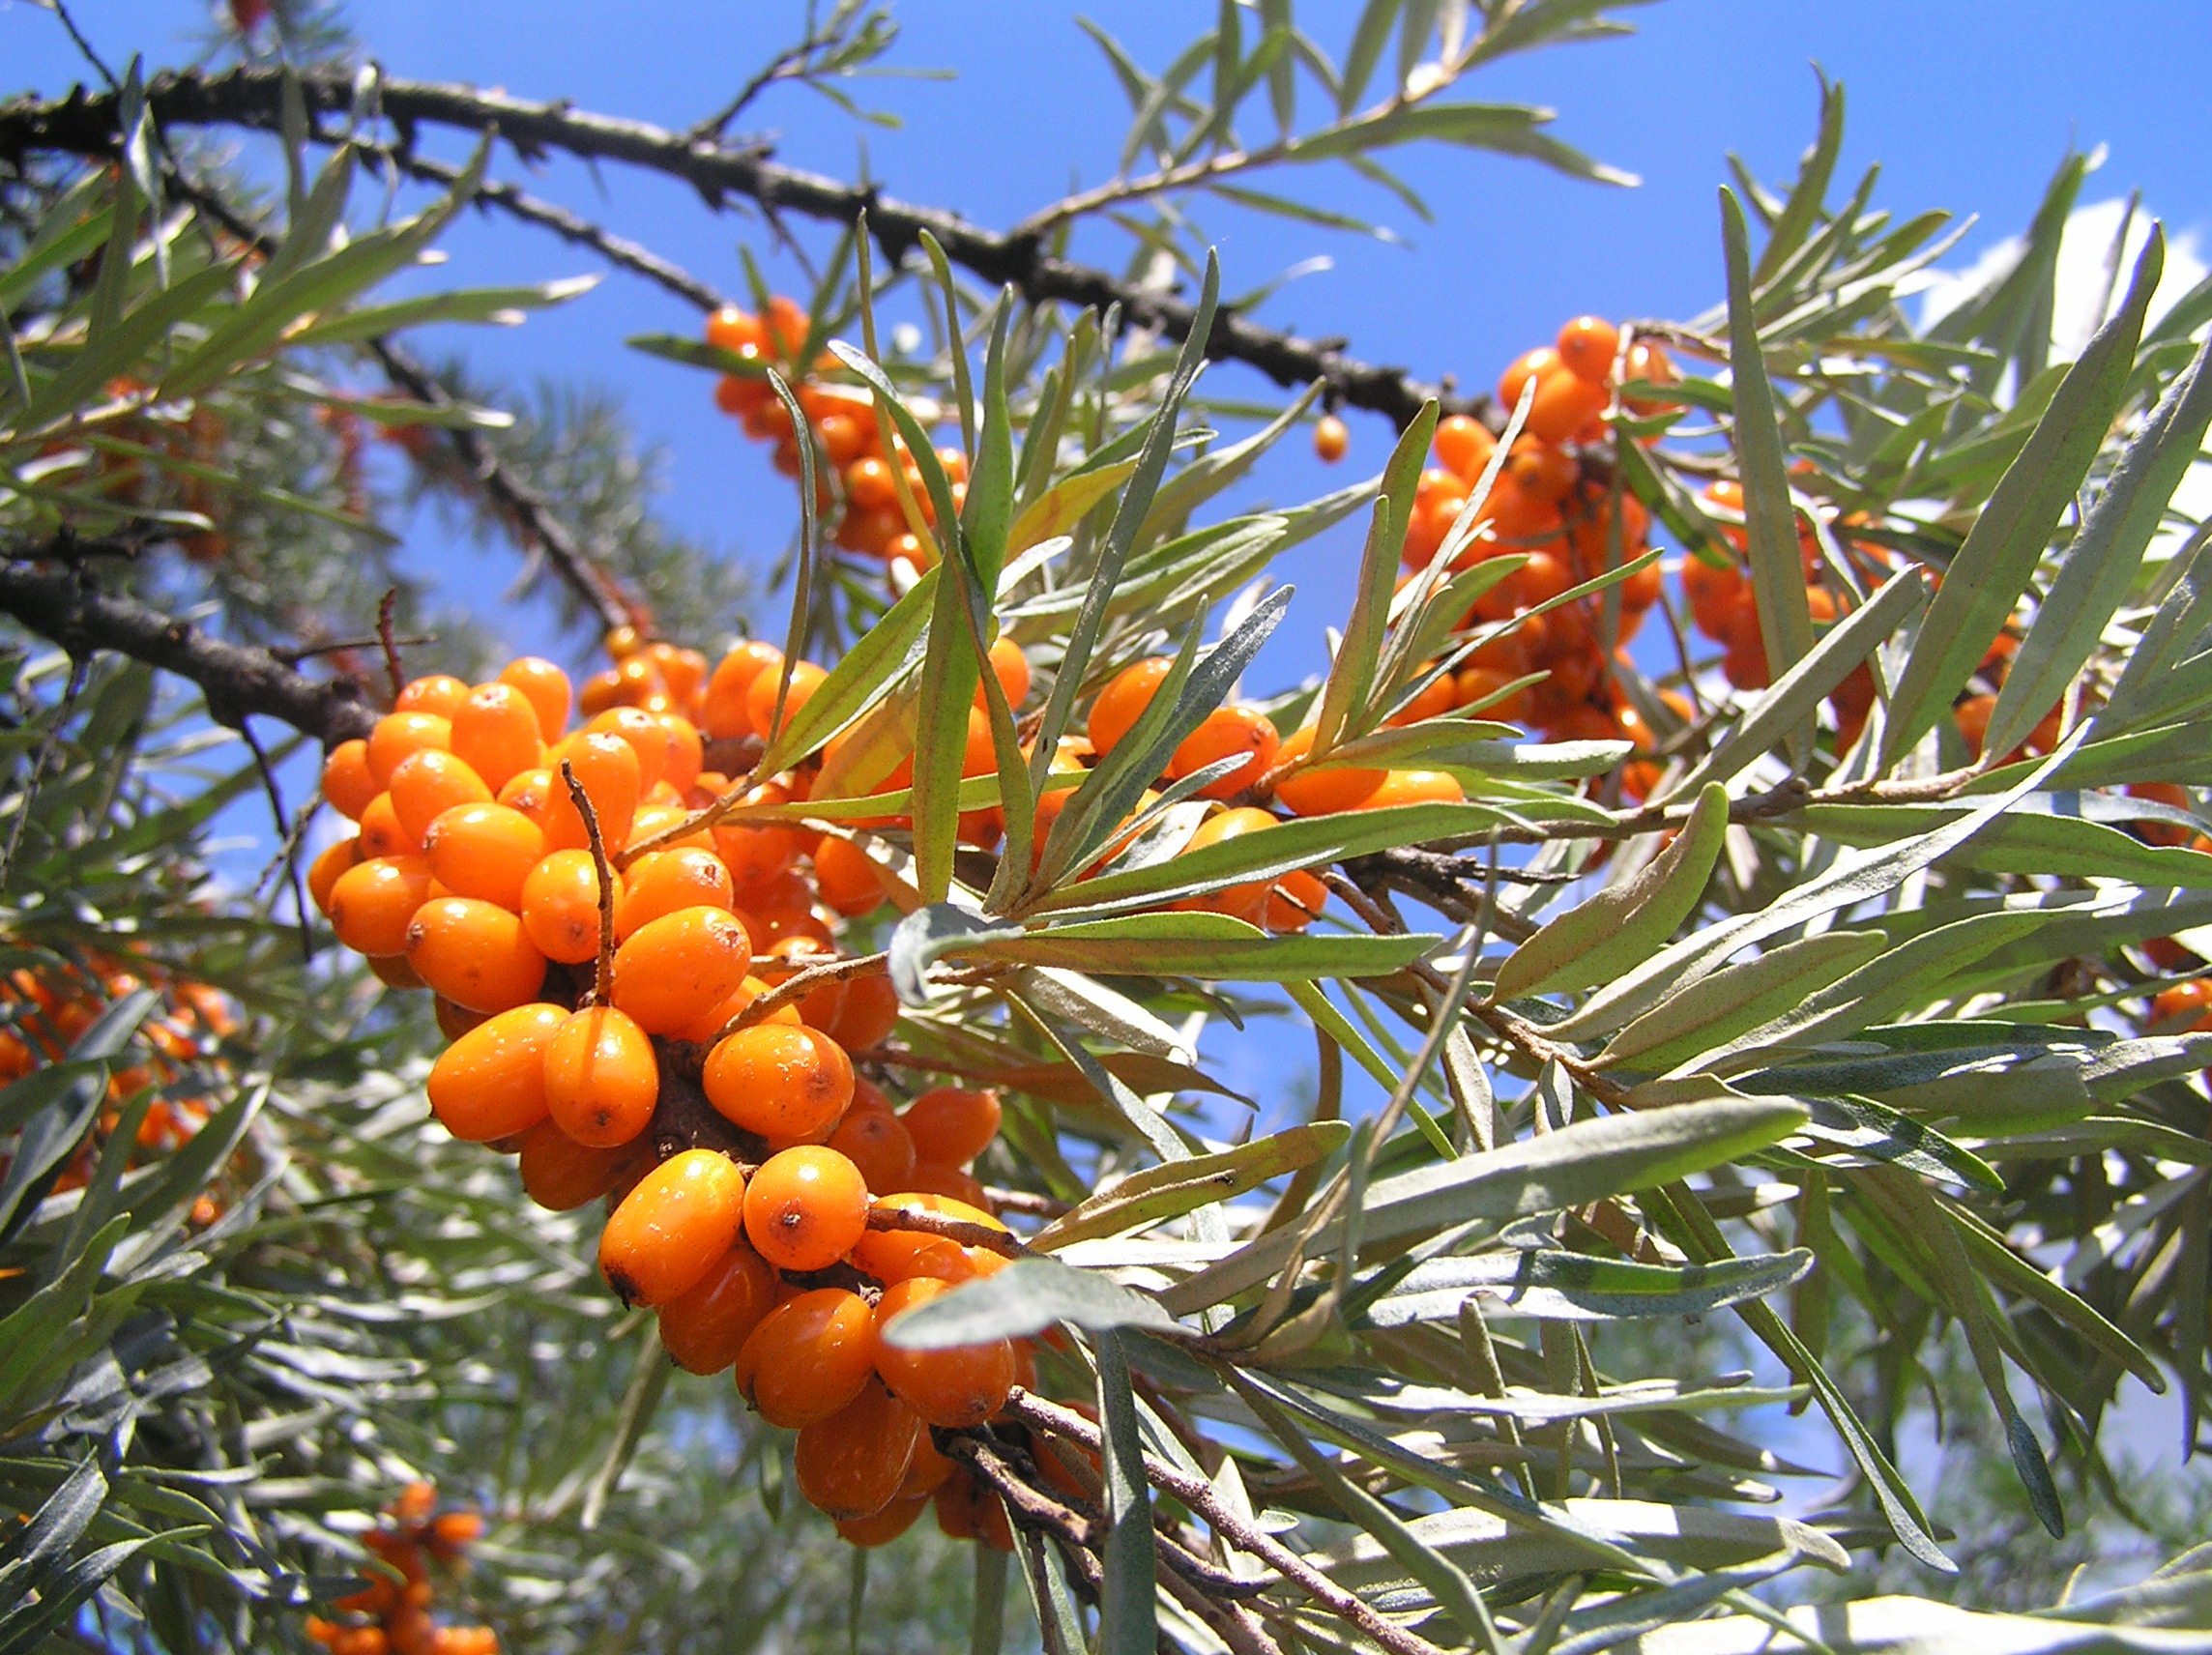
[706,297,967,573]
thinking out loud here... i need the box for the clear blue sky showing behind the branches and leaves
[16,0,2212,677]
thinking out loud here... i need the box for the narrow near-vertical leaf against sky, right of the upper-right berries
[1721,189,1812,747]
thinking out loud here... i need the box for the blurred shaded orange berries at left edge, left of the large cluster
[0,958,239,1224]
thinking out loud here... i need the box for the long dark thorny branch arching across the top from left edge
[0,67,1487,427]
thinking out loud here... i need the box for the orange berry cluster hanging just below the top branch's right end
[1398,316,1674,786]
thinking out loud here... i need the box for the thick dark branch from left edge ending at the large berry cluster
[0,544,376,748]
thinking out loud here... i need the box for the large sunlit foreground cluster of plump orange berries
[309,639,1065,1545]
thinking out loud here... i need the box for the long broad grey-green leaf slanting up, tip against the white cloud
[1882,230,2166,768]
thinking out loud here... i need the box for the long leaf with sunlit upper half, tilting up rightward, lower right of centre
[1161,1087,1807,1315]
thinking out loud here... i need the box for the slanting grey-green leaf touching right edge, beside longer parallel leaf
[1982,327,2212,752]
